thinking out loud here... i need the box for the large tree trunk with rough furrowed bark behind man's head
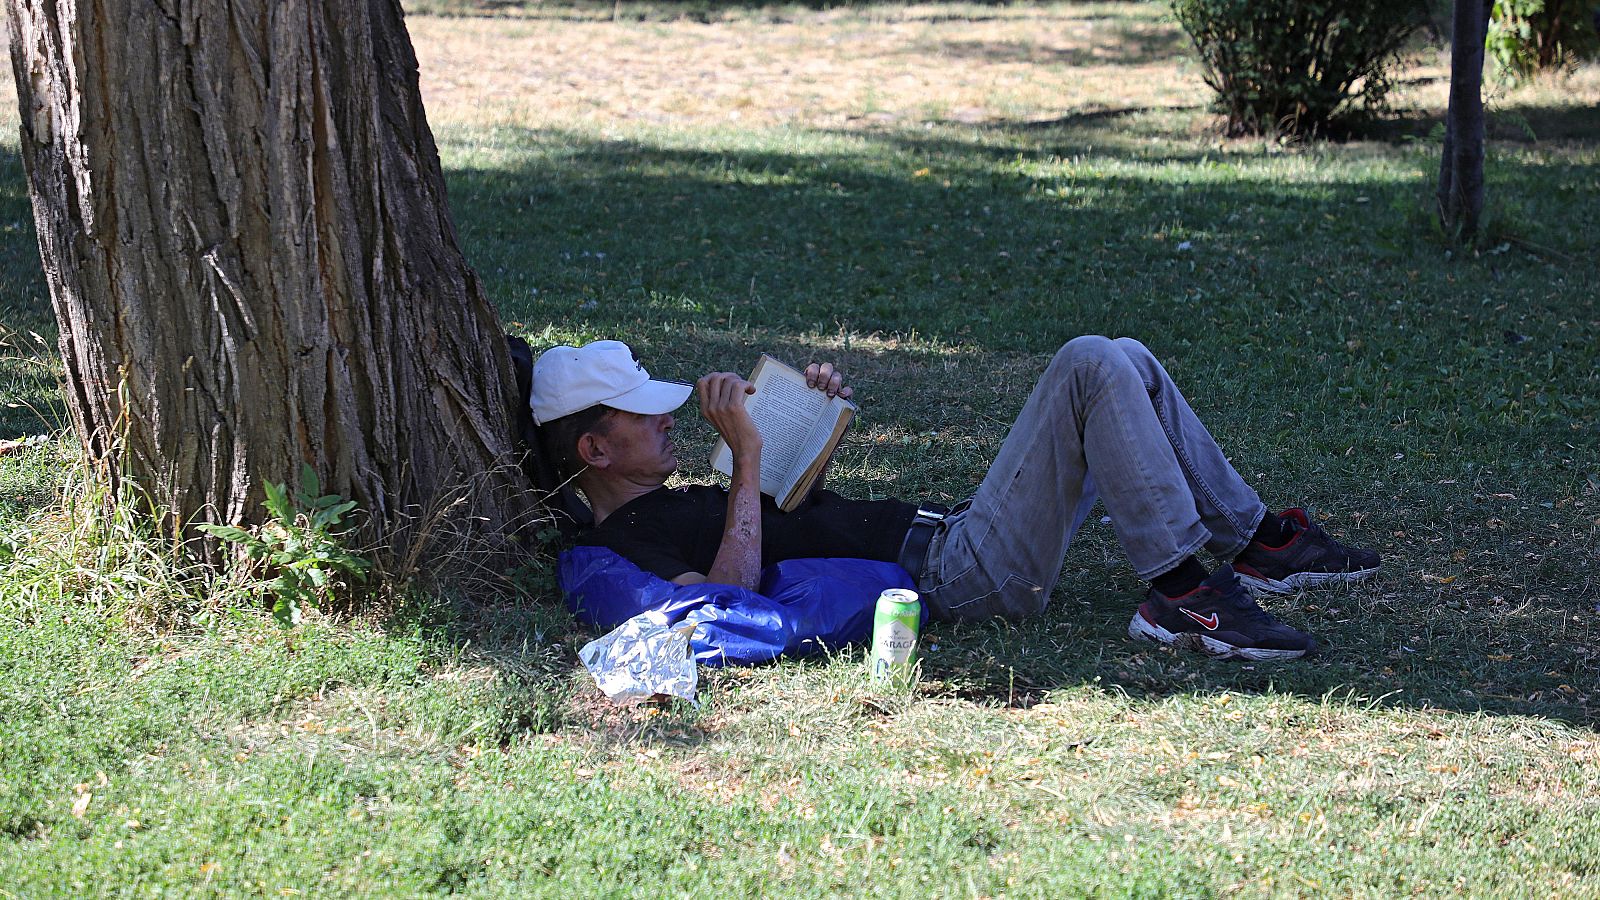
[6,0,530,560]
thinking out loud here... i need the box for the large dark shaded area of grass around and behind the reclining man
[432,122,1600,724]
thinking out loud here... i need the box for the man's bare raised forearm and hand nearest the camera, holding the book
[672,372,762,591]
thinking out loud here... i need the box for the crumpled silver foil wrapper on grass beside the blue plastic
[578,612,699,706]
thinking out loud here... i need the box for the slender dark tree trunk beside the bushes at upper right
[1438,0,1488,242]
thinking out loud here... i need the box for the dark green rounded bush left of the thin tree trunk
[1173,0,1426,135]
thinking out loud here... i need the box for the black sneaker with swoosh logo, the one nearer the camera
[1128,565,1317,660]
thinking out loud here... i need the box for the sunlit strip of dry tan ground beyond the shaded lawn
[410,3,1203,128]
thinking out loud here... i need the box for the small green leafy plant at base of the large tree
[200,464,371,628]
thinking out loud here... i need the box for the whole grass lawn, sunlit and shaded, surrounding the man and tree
[0,5,1600,897]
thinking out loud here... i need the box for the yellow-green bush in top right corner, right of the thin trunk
[1488,0,1600,78]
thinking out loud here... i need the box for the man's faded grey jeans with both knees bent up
[922,336,1266,618]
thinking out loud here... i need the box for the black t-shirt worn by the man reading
[578,485,917,580]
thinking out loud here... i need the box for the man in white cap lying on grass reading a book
[530,336,1378,660]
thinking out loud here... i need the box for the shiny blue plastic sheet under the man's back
[558,546,928,666]
